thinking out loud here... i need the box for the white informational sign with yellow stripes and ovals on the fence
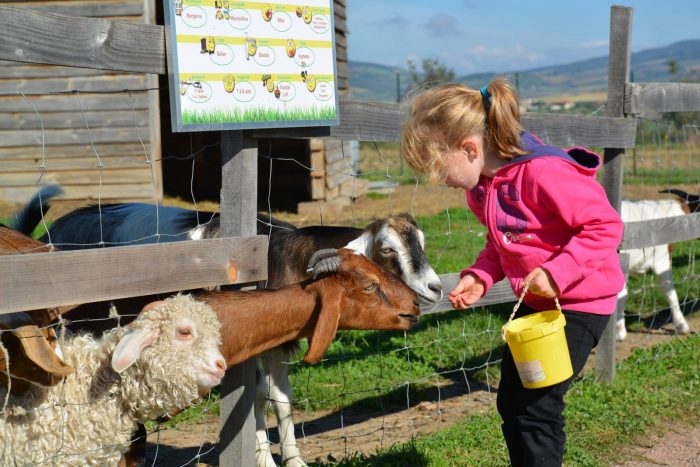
[165,0,338,131]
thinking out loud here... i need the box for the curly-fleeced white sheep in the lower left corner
[0,295,226,466]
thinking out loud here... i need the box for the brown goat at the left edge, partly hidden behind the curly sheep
[0,226,74,394]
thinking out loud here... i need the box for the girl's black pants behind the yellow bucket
[496,305,610,467]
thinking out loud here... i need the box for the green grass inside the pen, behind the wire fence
[171,208,700,444]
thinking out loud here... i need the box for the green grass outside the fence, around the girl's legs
[310,334,700,467]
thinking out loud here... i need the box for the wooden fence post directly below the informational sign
[219,131,258,467]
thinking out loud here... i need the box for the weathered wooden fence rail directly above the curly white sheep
[0,236,267,313]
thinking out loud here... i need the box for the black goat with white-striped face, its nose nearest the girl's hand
[14,187,442,467]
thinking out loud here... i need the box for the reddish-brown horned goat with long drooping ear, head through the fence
[196,249,420,365]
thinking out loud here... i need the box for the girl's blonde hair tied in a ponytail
[401,78,526,182]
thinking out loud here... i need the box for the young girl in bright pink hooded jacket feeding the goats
[401,79,624,466]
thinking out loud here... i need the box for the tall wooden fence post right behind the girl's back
[596,6,632,382]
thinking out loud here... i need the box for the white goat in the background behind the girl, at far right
[616,189,700,341]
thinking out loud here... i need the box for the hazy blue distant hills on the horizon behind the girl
[348,39,700,102]
